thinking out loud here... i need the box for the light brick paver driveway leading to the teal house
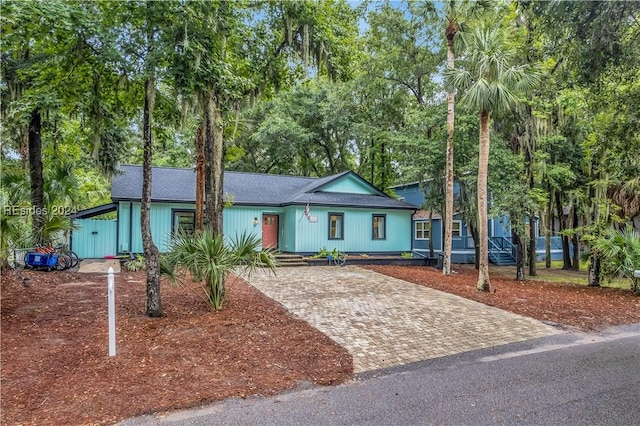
[250,266,558,373]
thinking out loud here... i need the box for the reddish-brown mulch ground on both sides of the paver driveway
[0,266,640,425]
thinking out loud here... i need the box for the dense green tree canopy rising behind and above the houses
[0,0,640,290]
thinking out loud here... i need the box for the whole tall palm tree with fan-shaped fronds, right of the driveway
[445,24,538,291]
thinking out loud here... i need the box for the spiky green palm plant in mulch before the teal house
[161,229,276,310]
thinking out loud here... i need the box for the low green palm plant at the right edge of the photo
[591,226,640,294]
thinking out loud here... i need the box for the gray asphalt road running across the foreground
[122,324,640,426]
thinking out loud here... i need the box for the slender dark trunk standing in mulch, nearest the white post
[140,78,162,317]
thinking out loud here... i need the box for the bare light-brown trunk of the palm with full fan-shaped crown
[477,111,490,291]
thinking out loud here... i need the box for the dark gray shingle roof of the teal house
[111,165,415,210]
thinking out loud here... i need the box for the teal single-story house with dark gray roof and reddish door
[71,165,416,258]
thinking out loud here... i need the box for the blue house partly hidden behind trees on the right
[391,182,562,265]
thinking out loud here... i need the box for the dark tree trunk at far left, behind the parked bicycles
[28,108,47,244]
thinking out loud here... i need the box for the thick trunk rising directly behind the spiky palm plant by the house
[204,89,224,234]
